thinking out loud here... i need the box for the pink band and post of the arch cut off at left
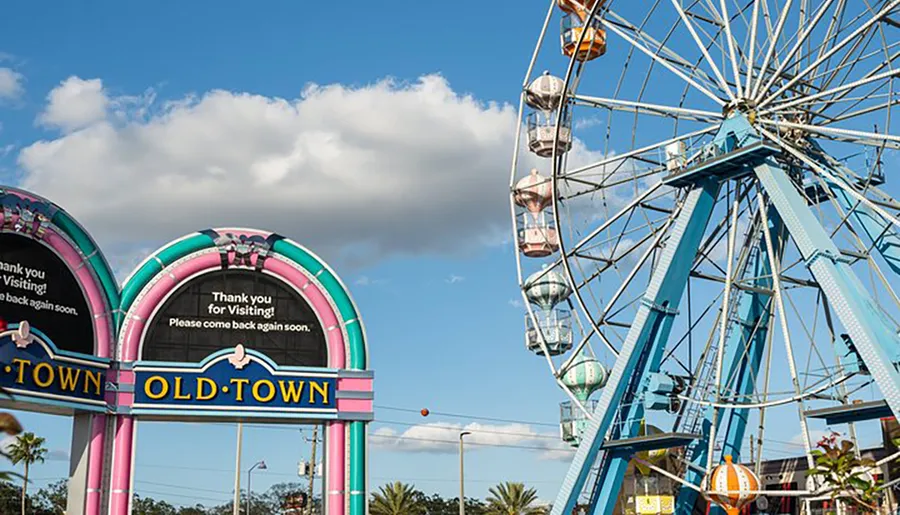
[0,216,113,515]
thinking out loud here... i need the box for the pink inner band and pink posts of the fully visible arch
[109,245,346,515]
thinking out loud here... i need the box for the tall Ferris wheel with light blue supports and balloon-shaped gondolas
[510,0,900,515]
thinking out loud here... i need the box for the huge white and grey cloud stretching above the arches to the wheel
[18,75,612,266]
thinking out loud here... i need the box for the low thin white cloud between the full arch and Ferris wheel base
[370,423,574,460]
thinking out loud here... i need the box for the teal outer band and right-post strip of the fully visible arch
[116,229,368,515]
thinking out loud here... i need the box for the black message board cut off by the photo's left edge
[0,232,94,355]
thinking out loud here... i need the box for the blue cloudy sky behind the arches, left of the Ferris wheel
[0,0,892,504]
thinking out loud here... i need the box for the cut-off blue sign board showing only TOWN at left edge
[0,322,109,411]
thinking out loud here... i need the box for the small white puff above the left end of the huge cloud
[38,76,110,131]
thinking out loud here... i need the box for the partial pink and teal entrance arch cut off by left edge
[0,187,119,515]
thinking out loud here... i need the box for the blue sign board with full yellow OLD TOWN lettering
[132,345,338,418]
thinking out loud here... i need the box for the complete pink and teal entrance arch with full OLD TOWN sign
[108,229,374,515]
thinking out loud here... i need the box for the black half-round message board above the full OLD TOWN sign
[141,269,328,367]
